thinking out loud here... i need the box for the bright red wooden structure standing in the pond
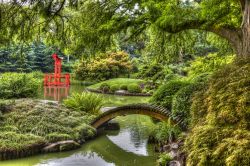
[43,54,70,86]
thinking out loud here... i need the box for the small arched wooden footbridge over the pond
[91,104,185,128]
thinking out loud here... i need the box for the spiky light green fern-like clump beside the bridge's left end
[63,92,103,114]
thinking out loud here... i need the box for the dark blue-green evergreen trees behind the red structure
[0,42,71,72]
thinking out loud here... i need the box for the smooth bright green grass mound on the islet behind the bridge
[88,78,144,89]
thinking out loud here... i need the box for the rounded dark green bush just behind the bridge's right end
[150,80,188,110]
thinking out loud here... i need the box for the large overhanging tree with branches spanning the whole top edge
[0,0,250,57]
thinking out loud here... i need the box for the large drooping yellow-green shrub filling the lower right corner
[185,58,250,166]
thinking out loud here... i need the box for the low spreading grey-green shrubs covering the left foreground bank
[0,99,95,152]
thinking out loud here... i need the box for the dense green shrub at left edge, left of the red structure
[0,73,41,99]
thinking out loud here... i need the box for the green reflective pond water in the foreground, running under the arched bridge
[0,115,157,166]
